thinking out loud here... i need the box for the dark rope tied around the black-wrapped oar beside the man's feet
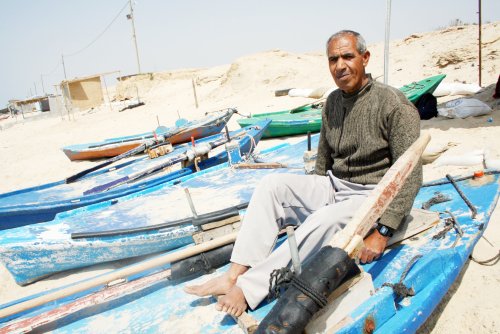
[268,267,328,308]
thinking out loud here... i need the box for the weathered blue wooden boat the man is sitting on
[0,167,500,333]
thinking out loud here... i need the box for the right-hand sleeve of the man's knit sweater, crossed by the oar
[380,104,422,229]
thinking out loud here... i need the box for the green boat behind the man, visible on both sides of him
[237,74,446,138]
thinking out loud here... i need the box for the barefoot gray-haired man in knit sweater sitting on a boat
[185,30,422,316]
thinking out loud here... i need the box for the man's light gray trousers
[231,174,375,309]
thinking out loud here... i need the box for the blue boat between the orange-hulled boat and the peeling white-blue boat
[0,121,269,230]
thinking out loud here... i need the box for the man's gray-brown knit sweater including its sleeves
[316,79,422,229]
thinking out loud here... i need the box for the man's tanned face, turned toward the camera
[327,35,370,93]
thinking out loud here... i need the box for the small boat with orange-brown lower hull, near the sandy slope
[62,109,235,161]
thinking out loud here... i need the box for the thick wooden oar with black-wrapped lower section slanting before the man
[257,134,430,333]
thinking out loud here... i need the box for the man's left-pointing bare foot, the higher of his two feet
[184,263,248,297]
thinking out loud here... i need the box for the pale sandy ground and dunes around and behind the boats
[0,22,500,333]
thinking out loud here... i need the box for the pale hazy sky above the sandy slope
[0,0,500,108]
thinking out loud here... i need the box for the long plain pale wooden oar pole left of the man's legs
[0,232,237,318]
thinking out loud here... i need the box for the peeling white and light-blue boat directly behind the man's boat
[0,120,278,285]
